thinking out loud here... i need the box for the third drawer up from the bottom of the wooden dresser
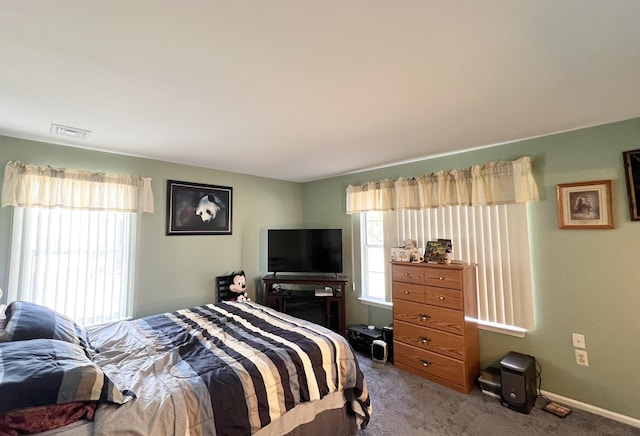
[393,300,464,335]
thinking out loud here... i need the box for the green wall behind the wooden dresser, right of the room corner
[303,119,640,419]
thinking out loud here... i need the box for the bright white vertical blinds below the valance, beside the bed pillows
[8,207,136,325]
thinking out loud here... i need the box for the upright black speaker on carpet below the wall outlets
[500,351,538,413]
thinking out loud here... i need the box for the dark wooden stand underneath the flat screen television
[262,274,348,336]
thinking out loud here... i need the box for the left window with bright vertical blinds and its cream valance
[2,161,154,325]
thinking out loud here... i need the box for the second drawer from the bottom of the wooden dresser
[393,321,464,359]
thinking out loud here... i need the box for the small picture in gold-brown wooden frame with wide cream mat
[556,180,613,229]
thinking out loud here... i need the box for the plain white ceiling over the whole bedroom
[0,0,640,182]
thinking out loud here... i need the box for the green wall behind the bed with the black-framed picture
[0,136,302,317]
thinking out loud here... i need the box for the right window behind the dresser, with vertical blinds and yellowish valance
[346,156,538,336]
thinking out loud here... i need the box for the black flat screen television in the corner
[267,229,342,274]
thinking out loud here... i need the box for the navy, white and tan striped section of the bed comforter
[134,302,370,435]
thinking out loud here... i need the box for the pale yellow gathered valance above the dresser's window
[347,156,538,214]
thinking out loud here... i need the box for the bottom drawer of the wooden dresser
[393,342,465,385]
